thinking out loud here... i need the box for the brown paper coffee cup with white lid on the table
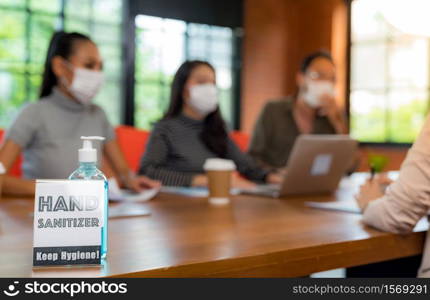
[203,158,236,205]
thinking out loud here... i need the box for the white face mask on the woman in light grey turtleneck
[61,63,103,105]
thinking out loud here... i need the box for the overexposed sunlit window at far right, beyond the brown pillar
[350,0,430,143]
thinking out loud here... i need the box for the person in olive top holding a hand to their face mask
[249,52,347,169]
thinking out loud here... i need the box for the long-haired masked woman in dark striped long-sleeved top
[140,61,280,186]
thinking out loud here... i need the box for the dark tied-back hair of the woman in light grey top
[40,31,91,98]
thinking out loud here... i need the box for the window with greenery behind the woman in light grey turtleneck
[0,0,122,128]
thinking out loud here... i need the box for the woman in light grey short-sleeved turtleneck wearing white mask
[0,32,159,195]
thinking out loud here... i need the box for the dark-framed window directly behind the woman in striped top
[134,15,238,129]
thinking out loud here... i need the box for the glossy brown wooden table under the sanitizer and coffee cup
[0,175,427,277]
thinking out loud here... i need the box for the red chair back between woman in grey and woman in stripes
[115,125,150,172]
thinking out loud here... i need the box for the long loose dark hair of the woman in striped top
[163,60,228,158]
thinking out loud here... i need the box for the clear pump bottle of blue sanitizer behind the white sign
[69,136,109,258]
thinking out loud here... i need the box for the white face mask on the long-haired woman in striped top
[188,83,218,116]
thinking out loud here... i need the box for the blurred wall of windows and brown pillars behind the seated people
[0,0,430,169]
